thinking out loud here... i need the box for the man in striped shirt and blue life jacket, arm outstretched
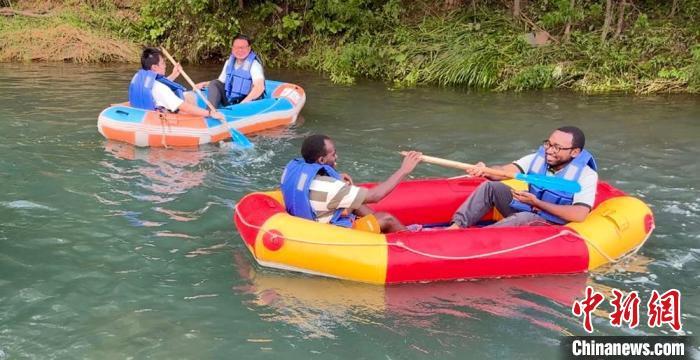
[282,135,421,233]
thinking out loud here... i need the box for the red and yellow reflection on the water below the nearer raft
[233,251,648,338]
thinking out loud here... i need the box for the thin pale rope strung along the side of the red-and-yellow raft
[234,204,649,264]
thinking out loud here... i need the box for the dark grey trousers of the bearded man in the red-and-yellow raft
[452,181,547,228]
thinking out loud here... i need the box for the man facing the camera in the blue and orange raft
[197,34,265,108]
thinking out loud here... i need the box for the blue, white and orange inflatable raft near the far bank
[97,80,306,147]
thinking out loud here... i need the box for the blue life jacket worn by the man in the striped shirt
[281,158,355,227]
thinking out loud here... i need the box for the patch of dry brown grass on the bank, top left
[0,1,140,63]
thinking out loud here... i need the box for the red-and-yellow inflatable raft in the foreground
[233,178,654,284]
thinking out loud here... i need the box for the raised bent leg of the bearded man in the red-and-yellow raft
[451,181,513,228]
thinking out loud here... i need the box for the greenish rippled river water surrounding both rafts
[0,64,700,360]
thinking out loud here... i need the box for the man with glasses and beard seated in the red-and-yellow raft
[450,126,598,229]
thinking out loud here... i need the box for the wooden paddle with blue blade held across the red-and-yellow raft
[401,151,581,193]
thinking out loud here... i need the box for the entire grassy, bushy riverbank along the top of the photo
[0,0,700,94]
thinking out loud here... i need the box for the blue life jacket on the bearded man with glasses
[510,146,598,224]
